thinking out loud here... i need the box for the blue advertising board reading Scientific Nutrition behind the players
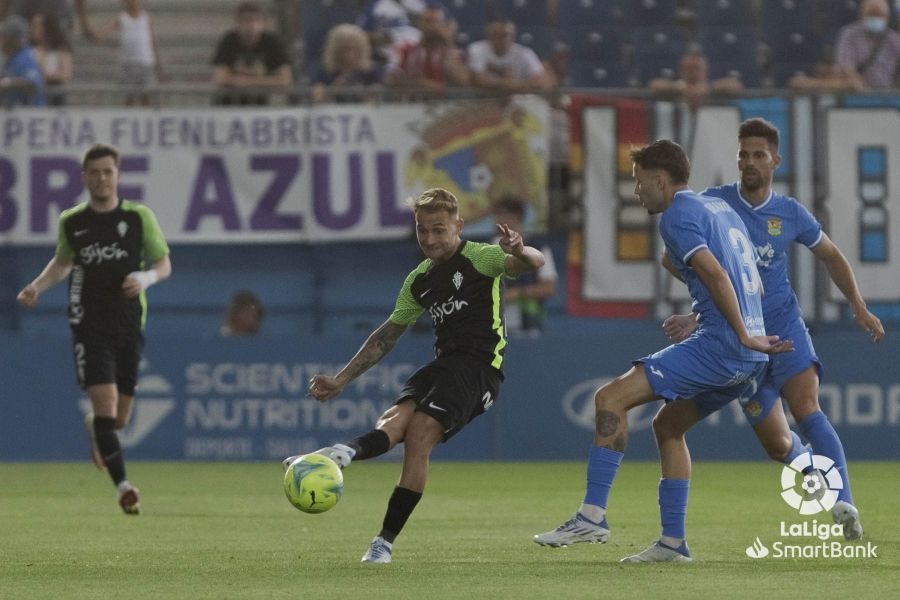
[0,324,900,461]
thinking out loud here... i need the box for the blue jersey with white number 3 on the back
[659,190,768,361]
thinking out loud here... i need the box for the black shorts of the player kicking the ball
[395,353,503,441]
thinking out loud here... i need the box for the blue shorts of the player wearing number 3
[633,337,768,419]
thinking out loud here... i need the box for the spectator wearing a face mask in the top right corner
[835,0,900,89]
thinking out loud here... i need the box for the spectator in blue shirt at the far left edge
[0,15,47,107]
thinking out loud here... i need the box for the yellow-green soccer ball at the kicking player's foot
[284,454,344,513]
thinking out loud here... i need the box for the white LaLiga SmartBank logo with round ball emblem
[744,453,878,559]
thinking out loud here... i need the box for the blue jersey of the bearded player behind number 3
[703,182,822,335]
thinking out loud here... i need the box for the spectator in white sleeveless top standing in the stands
[94,0,163,106]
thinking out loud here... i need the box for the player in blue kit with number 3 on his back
[534,140,791,563]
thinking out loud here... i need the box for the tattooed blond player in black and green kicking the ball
[285,188,544,563]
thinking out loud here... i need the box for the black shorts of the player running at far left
[72,324,144,396]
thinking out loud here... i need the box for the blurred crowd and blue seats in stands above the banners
[0,0,900,106]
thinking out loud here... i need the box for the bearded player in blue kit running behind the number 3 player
[660,118,884,540]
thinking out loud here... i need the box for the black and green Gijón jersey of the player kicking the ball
[390,240,506,370]
